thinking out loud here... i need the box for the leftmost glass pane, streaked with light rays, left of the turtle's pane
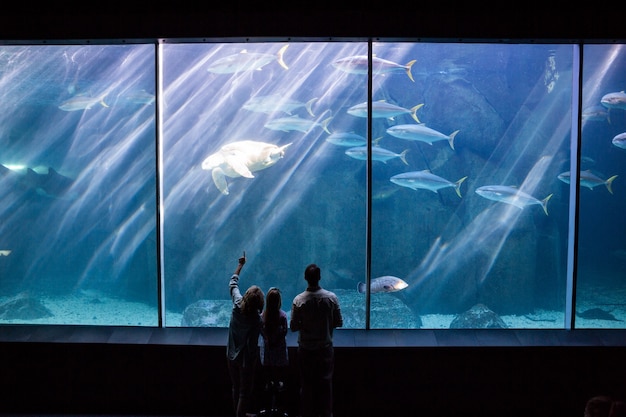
[0,45,158,326]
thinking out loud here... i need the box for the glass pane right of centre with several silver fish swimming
[371,42,573,328]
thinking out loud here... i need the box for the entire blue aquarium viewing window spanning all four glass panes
[0,39,626,330]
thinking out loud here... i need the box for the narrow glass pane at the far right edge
[568,45,626,328]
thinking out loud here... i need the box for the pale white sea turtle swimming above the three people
[202,140,291,195]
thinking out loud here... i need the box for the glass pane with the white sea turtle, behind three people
[162,42,367,328]
